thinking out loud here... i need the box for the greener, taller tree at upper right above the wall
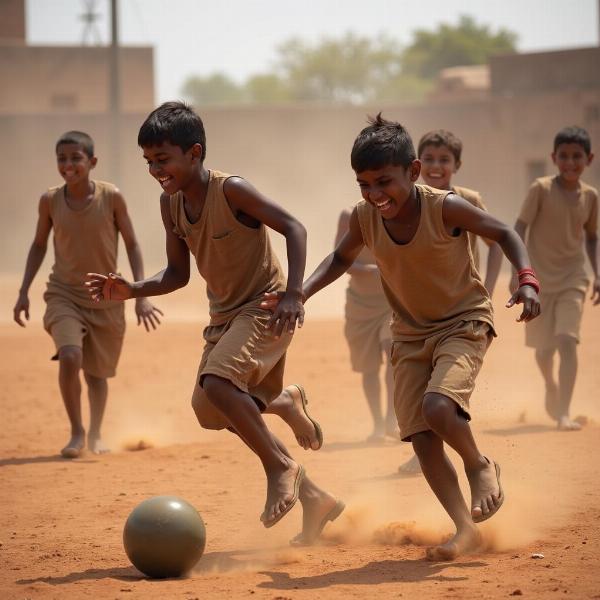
[402,15,517,79]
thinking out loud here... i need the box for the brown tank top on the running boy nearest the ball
[170,170,286,325]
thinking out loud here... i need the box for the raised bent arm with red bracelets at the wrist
[442,194,540,321]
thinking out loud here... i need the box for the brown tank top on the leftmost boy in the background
[47,181,118,308]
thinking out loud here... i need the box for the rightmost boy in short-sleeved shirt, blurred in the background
[515,127,600,431]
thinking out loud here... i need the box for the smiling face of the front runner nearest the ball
[142,142,202,194]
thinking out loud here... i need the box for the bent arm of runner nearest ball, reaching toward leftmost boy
[85,194,190,301]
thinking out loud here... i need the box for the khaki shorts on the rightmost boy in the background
[525,289,585,350]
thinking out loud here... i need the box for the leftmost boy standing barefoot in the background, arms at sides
[13,131,162,458]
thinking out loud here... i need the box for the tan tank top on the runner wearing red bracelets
[357,185,493,341]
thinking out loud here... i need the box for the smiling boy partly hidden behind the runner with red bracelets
[398,129,502,475]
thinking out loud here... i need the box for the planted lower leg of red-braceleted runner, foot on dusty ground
[411,431,481,560]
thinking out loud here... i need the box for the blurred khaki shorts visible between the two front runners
[344,294,392,373]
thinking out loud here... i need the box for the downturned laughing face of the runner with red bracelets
[356,160,421,219]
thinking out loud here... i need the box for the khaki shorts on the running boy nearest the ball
[192,307,292,429]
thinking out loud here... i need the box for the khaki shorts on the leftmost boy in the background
[44,293,125,378]
